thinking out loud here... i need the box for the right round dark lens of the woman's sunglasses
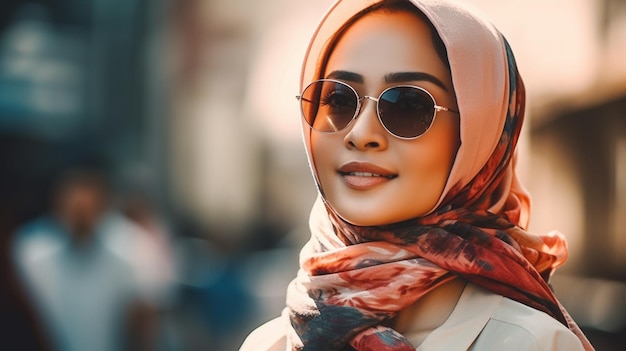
[378,87,435,138]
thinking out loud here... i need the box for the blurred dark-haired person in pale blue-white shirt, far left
[13,168,161,351]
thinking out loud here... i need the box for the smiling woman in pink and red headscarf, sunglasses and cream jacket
[241,0,593,351]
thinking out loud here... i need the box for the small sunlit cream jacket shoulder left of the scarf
[239,317,287,351]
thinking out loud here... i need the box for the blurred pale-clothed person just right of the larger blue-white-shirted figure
[114,167,179,348]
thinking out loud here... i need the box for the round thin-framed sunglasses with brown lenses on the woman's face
[296,79,459,139]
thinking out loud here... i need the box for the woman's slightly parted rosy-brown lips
[338,162,398,190]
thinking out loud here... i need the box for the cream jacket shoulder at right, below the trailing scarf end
[472,292,583,351]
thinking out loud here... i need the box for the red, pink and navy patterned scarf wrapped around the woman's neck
[285,0,593,351]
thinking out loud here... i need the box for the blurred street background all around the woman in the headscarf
[0,0,626,350]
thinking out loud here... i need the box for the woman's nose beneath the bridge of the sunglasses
[344,97,389,150]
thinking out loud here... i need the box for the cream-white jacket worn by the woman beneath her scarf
[240,284,584,351]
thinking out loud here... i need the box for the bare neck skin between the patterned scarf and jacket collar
[392,278,467,347]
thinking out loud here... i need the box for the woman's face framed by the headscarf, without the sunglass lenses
[311,12,460,226]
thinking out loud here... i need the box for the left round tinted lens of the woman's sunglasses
[300,81,358,132]
